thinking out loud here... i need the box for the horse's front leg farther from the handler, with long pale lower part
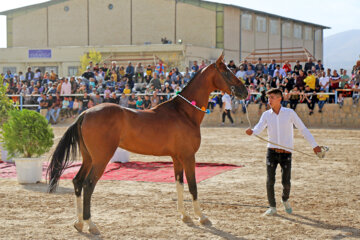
[173,157,191,222]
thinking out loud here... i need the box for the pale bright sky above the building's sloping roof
[0,0,360,48]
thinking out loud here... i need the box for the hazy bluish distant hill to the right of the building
[324,29,360,70]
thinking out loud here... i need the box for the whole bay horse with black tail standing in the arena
[47,54,248,234]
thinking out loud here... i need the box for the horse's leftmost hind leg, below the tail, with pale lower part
[73,153,91,232]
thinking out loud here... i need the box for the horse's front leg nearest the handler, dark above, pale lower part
[184,156,211,225]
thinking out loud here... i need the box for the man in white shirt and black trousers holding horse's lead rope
[246,88,321,216]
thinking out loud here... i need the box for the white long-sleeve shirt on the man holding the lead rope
[253,107,318,152]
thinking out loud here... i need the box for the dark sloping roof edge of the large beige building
[0,0,330,29]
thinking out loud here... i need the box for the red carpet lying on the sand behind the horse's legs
[0,162,241,182]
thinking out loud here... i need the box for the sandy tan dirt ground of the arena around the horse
[0,126,360,239]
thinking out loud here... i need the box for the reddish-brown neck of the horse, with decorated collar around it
[178,71,215,125]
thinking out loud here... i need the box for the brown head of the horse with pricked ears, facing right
[213,54,248,99]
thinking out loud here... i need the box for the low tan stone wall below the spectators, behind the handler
[202,98,360,129]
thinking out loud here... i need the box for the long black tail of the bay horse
[46,113,85,193]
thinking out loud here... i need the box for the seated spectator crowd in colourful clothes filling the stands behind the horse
[0,58,360,124]
